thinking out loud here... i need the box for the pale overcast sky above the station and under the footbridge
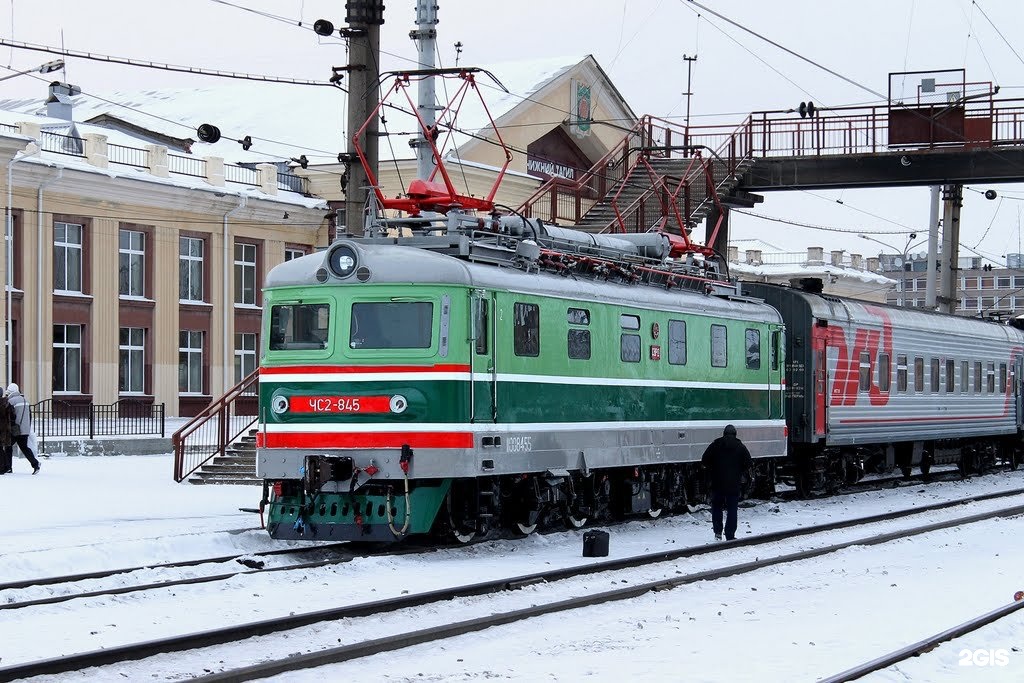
[0,0,1024,262]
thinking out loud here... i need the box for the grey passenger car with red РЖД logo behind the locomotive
[744,280,1024,489]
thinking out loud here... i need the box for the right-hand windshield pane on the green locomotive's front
[348,301,434,349]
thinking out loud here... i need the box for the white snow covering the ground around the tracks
[0,456,1024,681]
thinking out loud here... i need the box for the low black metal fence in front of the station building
[32,398,165,445]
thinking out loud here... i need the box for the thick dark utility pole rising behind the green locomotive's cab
[342,0,384,234]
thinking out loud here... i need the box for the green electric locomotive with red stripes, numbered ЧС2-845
[257,224,786,542]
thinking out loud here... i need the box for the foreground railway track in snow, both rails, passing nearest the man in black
[0,489,1024,681]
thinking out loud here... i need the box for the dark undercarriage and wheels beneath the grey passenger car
[779,436,1024,497]
